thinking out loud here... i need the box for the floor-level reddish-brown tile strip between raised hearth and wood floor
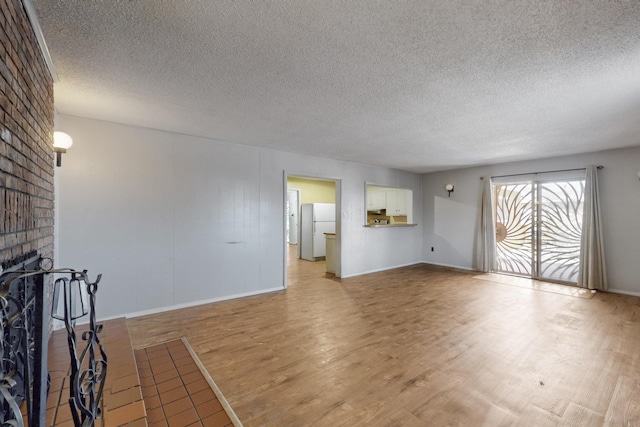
[135,340,233,427]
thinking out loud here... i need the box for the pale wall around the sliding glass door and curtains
[422,147,640,295]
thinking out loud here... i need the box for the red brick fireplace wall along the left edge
[0,0,54,262]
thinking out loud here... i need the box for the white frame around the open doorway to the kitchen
[281,169,342,289]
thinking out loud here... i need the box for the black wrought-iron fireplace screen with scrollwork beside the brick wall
[0,252,107,427]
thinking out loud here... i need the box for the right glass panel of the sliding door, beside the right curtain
[538,180,584,282]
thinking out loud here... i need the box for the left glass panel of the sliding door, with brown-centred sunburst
[494,182,534,276]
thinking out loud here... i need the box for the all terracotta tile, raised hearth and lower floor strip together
[40,318,242,427]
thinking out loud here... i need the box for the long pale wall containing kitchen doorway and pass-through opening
[56,115,423,318]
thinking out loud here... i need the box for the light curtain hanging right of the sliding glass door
[578,166,608,290]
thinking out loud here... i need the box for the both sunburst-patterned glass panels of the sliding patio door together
[493,179,585,283]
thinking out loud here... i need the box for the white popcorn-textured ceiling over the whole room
[33,0,640,172]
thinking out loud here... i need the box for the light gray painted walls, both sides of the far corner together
[56,115,640,318]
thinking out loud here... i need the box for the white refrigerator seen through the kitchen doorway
[299,203,336,261]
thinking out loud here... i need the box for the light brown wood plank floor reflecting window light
[129,246,640,426]
